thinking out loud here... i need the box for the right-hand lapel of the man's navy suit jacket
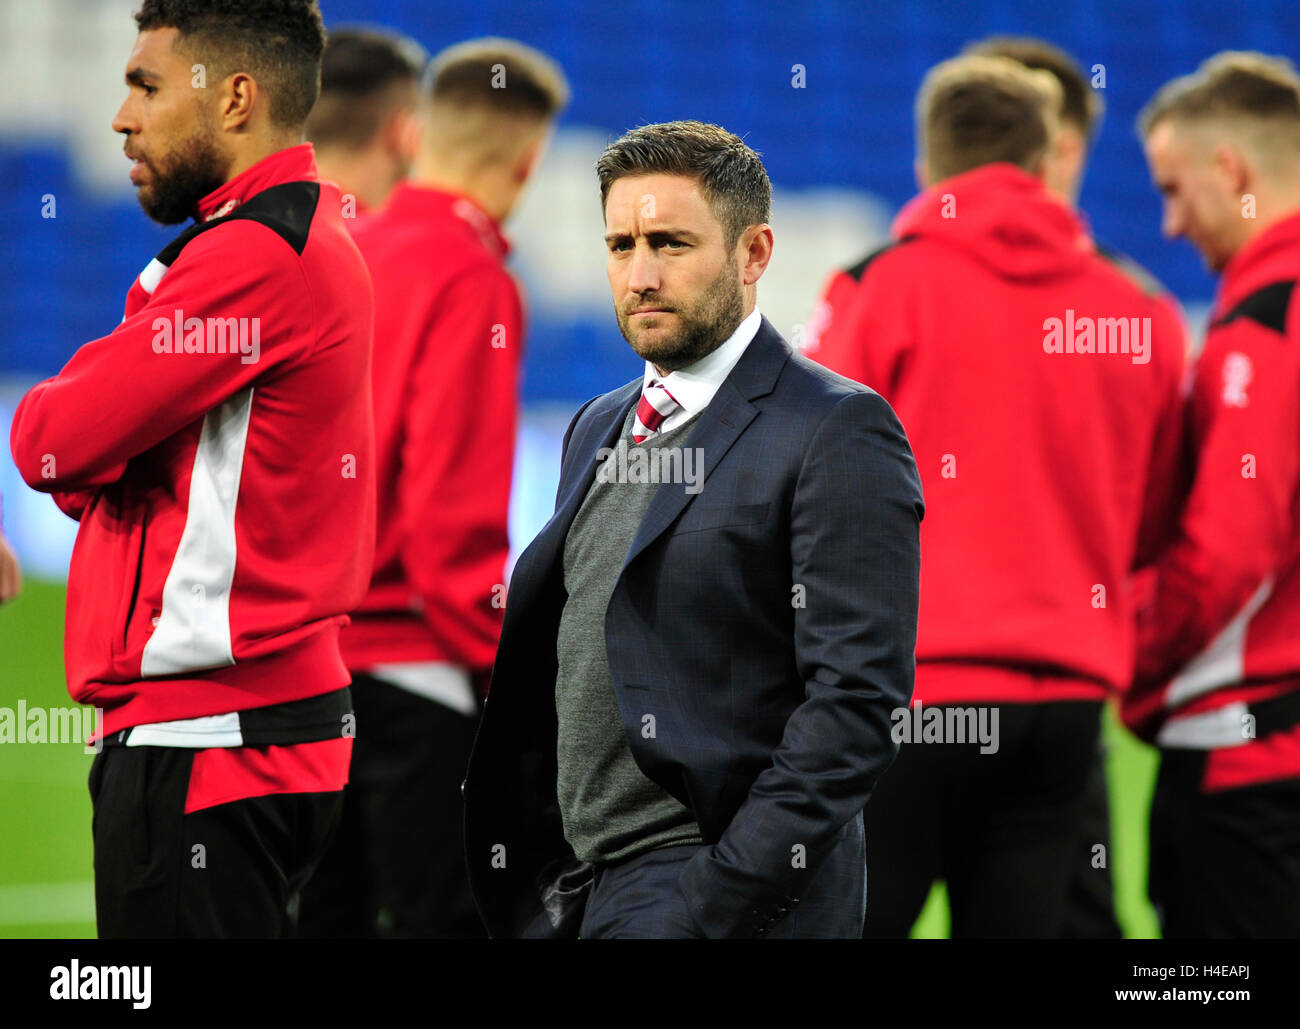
[621,318,792,568]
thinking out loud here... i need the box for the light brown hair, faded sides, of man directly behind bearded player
[425,36,569,121]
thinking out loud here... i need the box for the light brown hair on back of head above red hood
[917,55,1062,182]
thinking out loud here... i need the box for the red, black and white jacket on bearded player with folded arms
[10,144,374,734]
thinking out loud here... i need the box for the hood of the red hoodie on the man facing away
[893,162,1093,279]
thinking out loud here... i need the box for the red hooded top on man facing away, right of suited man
[807,164,1183,703]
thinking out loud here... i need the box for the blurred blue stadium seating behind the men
[0,0,1300,400]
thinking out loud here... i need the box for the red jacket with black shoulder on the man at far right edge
[1123,206,1300,785]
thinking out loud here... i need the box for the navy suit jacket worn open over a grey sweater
[463,318,924,937]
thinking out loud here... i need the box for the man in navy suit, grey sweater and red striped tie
[464,122,923,938]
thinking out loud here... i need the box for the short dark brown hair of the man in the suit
[595,121,772,247]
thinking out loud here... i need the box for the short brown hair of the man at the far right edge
[1138,51,1300,143]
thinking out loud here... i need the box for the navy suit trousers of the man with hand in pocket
[579,815,867,939]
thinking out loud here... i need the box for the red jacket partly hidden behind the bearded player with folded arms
[343,183,524,682]
